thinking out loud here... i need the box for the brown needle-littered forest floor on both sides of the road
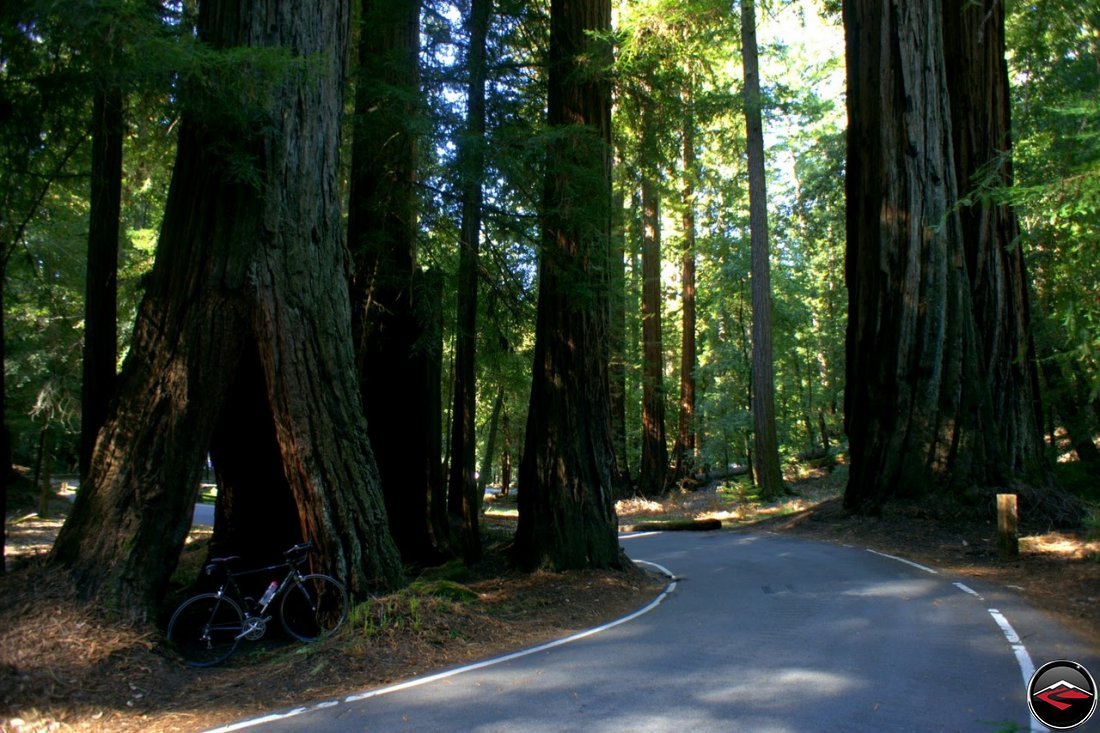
[0,467,1100,733]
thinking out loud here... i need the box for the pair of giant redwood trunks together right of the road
[844,0,1040,512]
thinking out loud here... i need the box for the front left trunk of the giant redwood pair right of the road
[845,0,1007,512]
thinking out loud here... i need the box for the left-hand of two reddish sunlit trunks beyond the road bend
[638,174,669,496]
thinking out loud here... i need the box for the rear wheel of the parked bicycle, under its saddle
[167,593,244,667]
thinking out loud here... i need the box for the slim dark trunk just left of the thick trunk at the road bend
[448,0,493,562]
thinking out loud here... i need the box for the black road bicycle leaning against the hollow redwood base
[167,534,348,667]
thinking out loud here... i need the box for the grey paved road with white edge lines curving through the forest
[204,532,1100,733]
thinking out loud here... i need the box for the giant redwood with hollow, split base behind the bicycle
[52,0,402,617]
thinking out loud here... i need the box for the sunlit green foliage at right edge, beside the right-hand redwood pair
[999,0,1100,401]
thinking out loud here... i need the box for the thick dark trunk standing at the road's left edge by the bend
[515,0,624,569]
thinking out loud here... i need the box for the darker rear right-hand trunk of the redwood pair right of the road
[943,0,1047,483]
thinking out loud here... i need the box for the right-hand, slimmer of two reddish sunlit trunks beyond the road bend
[673,112,696,480]
